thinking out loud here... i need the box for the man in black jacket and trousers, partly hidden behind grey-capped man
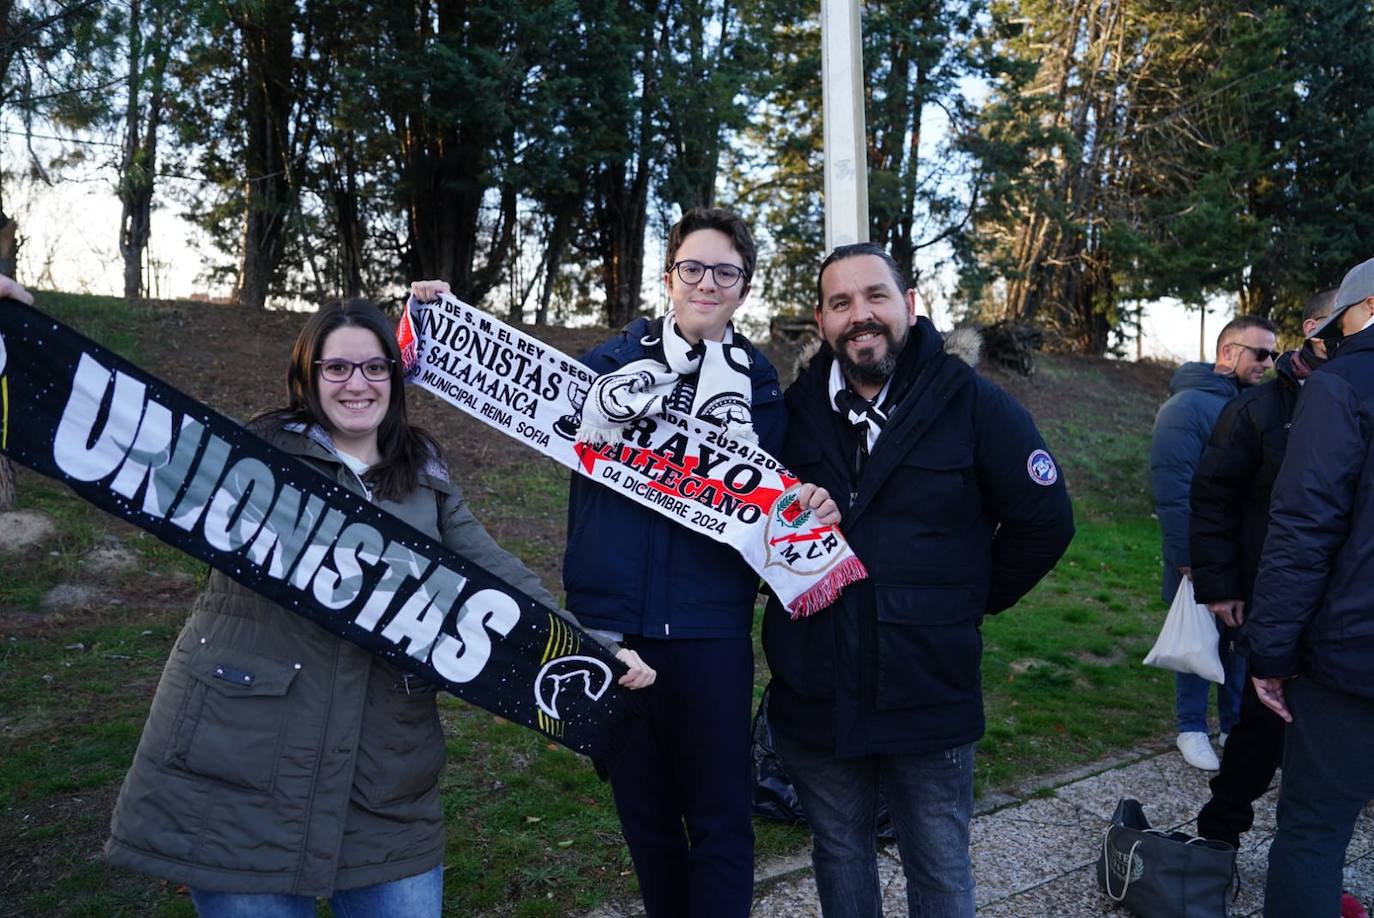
[1189,290,1336,848]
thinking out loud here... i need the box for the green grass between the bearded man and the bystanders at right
[977,395,1173,793]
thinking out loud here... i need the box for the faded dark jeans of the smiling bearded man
[774,734,973,918]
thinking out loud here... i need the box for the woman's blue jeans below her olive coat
[191,864,444,918]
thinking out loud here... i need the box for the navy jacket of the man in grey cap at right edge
[1245,322,1374,698]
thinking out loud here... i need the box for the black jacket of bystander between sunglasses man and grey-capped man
[1189,352,1301,609]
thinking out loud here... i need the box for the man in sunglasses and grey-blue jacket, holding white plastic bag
[1150,316,1279,771]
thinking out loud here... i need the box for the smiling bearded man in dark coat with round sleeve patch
[764,243,1073,918]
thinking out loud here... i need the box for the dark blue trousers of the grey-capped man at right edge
[1264,679,1374,918]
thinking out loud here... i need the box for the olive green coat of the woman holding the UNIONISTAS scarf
[104,430,556,896]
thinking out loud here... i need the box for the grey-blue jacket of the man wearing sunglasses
[1150,361,1241,603]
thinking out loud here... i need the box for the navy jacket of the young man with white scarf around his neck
[563,319,787,638]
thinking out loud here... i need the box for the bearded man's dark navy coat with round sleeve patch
[764,319,1073,757]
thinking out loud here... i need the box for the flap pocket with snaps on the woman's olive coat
[164,645,298,793]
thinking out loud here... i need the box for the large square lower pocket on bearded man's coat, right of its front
[875,584,982,709]
